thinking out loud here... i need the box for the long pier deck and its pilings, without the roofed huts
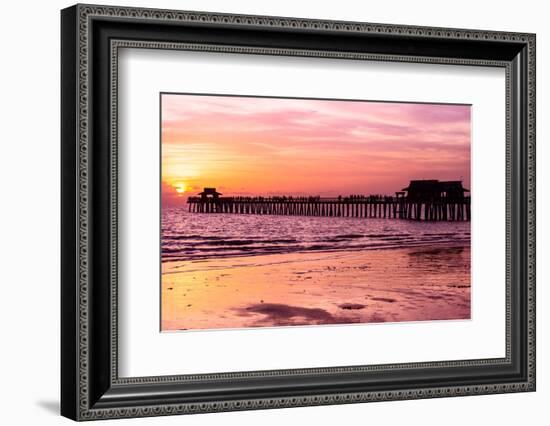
[187,196,471,221]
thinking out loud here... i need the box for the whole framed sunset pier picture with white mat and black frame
[61,5,535,420]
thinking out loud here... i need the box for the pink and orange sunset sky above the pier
[161,94,470,205]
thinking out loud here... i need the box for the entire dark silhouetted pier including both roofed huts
[187,180,471,221]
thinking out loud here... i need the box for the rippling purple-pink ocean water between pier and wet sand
[161,207,470,262]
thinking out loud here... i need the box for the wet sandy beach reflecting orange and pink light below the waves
[161,245,470,331]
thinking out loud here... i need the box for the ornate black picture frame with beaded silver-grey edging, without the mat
[61,5,535,420]
